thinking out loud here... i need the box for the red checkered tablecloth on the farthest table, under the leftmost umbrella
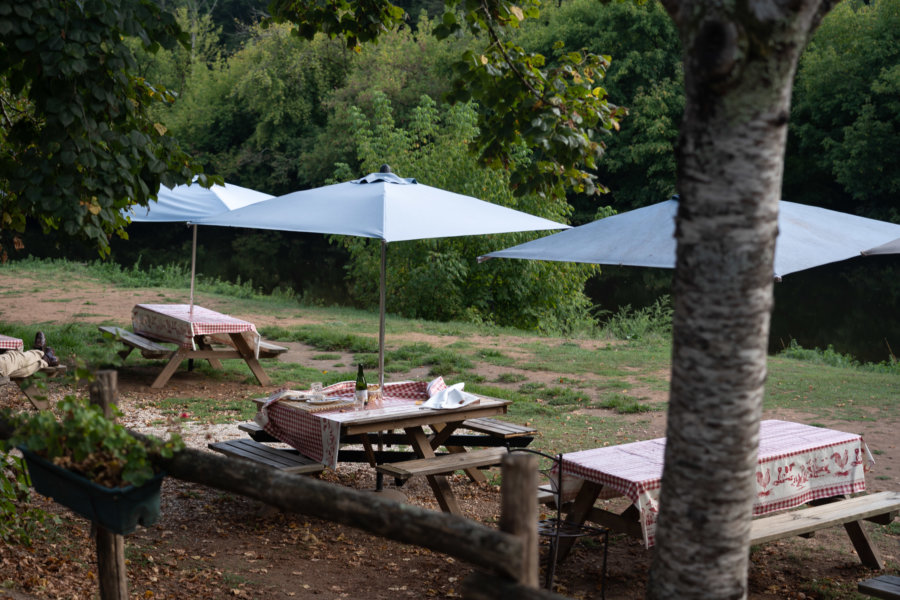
[131,304,259,349]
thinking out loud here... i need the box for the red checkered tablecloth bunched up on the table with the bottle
[257,377,447,469]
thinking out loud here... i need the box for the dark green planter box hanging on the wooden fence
[19,448,165,534]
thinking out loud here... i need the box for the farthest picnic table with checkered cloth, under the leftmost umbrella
[123,304,271,388]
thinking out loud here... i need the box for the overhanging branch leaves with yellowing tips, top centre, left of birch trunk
[270,0,623,202]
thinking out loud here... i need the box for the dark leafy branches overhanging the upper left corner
[0,0,206,254]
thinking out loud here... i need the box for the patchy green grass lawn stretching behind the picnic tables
[0,254,900,448]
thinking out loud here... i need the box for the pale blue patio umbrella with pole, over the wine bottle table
[192,167,569,385]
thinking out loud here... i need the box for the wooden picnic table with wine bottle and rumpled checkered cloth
[257,381,509,514]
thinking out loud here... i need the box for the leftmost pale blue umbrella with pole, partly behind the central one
[124,183,273,309]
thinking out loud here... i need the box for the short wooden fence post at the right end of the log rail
[500,452,538,588]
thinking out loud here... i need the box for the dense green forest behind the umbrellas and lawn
[8,0,900,362]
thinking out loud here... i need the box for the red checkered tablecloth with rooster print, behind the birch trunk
[562,420,874,548]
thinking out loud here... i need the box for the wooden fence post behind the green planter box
[90,371,128,600]
